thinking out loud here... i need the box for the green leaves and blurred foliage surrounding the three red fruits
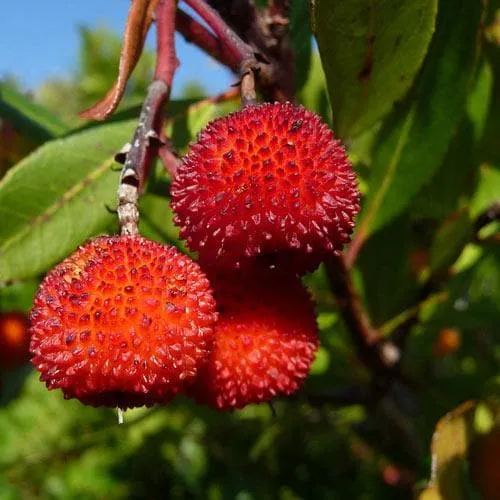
[0,0,500,500]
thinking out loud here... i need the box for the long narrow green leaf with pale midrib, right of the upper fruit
[358,0,483,240]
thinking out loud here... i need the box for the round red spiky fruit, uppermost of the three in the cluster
[171,103,359,271]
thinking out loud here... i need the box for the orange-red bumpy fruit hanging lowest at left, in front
[30,236,217,408]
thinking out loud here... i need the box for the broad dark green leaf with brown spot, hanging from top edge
[312,0,438,138]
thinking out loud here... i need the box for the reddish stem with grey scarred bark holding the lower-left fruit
[118,0,178,234]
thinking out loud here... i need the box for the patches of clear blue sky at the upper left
[0,0,234,95]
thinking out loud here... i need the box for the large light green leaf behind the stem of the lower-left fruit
[0,120,136,281]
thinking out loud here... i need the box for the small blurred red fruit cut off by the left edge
[0,312,29,370]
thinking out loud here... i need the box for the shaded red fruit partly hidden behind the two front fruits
[189,272,318,410]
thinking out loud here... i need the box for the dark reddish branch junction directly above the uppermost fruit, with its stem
[177,0,295,102]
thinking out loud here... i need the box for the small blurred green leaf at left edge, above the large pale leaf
[0,83,68,144]
